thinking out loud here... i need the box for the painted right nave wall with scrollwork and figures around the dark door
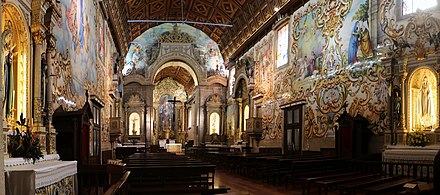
[230,0,388,146]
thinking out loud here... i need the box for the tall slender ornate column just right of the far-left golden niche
[31,23,47,154]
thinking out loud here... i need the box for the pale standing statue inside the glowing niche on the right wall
[417,76,436,129]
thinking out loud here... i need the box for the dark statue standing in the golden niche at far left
[1,29,15,117]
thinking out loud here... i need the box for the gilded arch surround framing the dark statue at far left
[1,2,33,118]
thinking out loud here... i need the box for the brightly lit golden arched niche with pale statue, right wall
[409,68,438,131]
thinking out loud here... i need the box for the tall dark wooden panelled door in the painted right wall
[284,105,303,154]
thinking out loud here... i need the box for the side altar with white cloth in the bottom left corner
[5,154,77,194]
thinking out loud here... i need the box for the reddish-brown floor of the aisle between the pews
[214,169,338,195]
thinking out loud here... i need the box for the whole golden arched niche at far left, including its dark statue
[1,3,32,120]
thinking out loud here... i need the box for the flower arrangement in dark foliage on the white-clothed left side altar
[8,114,43,164]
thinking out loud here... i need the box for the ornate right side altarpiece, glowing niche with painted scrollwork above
[378,0,440,138]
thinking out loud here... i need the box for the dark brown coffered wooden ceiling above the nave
[102,0,308,59]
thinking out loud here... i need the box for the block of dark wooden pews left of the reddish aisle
[127,154,229,194]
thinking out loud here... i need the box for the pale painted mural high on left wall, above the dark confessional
[54,0,98,94]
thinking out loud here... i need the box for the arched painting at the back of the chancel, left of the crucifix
[159,94,174,131]
